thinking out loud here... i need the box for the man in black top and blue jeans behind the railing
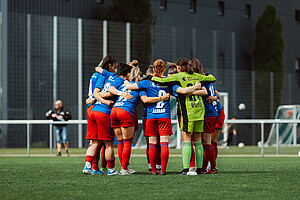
[46,100,72,156]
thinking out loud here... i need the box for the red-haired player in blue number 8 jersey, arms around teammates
[125,59,201,175]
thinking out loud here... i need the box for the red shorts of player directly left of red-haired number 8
[110,107,134,128]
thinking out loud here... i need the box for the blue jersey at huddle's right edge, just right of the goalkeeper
[202,83,219,117]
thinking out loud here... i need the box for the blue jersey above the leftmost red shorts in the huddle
[92,70,124,115]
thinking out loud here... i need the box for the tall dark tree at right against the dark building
[253,4,284,118]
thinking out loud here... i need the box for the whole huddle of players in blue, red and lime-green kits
[83,55,224,175]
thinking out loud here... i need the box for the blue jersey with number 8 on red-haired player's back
[137,80,175,119]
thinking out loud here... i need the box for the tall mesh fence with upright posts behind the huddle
[0,13,300,147]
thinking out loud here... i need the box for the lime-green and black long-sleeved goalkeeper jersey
[152,72,216,123]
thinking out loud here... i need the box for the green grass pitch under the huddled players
[0,149,300,200]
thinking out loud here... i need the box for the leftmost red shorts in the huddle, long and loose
[86,111,114,141]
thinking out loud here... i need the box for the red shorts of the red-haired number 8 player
[145,118,173,137]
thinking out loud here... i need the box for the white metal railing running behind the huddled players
[0,119,300,157]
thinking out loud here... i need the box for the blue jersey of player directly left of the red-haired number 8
[114,82,141,117]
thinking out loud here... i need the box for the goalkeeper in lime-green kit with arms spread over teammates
[152,58,216,175]
